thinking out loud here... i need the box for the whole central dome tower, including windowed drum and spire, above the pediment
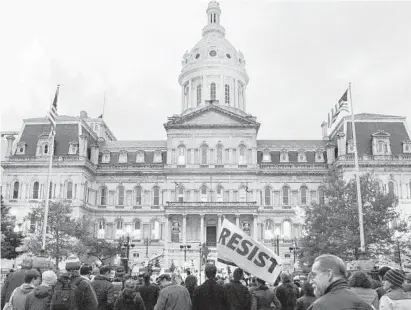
[178,1,248,113]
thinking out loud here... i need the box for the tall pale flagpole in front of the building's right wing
[348,83,366,259]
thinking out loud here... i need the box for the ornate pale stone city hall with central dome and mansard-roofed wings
[1,1,411,269]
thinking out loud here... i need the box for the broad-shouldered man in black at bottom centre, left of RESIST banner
[192,264,230,310]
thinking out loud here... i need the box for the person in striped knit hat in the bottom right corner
[380,269,411,310]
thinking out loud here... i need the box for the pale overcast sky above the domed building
[0,0,411,140]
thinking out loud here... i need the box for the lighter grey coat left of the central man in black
[154,284,191,310]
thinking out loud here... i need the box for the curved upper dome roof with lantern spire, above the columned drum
[180,1,248,82]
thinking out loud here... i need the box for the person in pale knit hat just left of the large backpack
[24,270,57,310]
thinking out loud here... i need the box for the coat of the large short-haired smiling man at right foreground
[308,279,372,310]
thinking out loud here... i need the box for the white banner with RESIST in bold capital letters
[217,220,282,283]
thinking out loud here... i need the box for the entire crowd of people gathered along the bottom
[1,255,411,310]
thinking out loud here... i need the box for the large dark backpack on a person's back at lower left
[50,277,79,310]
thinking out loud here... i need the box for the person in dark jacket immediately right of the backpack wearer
[90,266,114,310]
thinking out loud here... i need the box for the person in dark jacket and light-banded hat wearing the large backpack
[65,256,98,310]
